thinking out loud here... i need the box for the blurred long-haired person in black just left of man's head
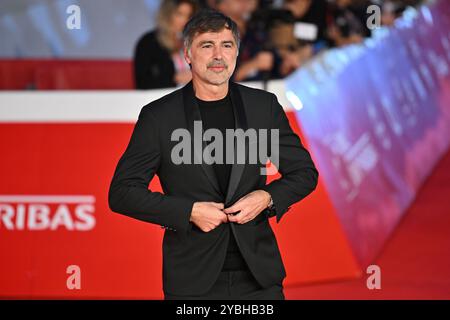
[134,0,198,89]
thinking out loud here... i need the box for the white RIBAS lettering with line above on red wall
[0,195,95,231]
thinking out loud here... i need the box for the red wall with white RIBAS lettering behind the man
[0,93,359,298]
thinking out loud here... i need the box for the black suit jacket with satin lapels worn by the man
[109,83,318,296]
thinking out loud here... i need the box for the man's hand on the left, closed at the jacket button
[190,202,228,232]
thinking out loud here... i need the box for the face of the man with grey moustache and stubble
[184,28,238,85]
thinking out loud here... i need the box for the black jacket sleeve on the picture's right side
[262,95,319,222]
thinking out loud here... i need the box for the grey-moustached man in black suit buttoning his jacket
[109,11,318,299]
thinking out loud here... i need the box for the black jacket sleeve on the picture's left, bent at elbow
[108,107,194,232]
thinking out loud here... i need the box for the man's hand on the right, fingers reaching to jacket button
[224,190,270,224]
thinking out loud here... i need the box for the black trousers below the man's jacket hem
[164,270,285,300]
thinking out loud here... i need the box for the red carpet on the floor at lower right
[285,148,450,299]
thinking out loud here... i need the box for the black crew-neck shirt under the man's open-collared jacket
[197,93,247,271]
